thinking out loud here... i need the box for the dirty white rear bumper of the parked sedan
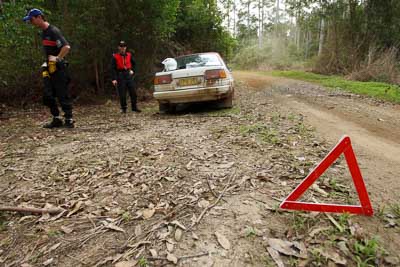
[153,85,233,103]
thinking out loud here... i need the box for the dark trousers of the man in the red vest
[117,72,137,110]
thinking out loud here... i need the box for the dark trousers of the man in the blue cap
[43,63,72,119]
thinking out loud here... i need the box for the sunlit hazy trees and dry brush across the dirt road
[228,0,400,83]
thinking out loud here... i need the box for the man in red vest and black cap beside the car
[111,41,141,113]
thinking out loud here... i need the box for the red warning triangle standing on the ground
[280,136,374,216]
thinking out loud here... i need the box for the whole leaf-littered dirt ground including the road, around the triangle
[0,72,400,266]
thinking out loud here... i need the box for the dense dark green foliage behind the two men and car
[0,0,234,102]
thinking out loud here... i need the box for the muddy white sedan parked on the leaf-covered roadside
[154,53,234,112]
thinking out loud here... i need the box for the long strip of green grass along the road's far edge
[269,71,400,103]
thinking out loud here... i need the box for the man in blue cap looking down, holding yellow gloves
[23,8,74,128]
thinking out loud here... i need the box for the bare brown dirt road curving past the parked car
[236,72,400,203]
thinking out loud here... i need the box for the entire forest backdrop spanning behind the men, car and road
[0,0,400,105]
